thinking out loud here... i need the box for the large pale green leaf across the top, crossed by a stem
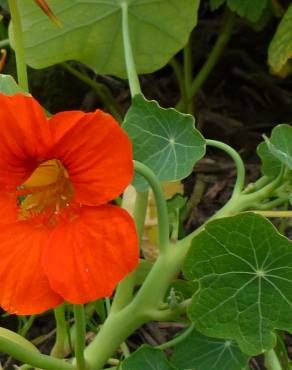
[12,0,199,78]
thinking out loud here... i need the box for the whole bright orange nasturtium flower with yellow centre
[0,94,138,314]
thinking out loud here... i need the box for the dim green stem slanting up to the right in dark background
[189,9,235,99]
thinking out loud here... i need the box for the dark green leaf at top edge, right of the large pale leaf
[210,0,268,22]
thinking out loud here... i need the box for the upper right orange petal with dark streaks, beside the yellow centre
[50,110,133,205]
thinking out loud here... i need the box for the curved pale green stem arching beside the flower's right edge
[134,161,169,253]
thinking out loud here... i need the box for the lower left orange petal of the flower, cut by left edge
[0,195,62,315]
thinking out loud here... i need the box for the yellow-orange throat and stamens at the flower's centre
[17,159,73,224]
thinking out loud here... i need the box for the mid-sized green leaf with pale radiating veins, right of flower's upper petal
[123,95,206,191]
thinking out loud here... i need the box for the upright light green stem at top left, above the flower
[8,0,29,92]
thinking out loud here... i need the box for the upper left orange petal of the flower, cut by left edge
[0,94,52,186]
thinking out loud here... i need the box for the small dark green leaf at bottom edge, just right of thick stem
[121,346,175,370]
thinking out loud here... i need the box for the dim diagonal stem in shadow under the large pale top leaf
[61,63,123,122]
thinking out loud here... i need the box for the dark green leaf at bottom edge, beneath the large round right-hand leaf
[170,330,248,370]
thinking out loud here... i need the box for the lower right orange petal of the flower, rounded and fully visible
[43,205,139,304]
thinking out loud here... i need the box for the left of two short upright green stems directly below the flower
[51,304,67,358]
